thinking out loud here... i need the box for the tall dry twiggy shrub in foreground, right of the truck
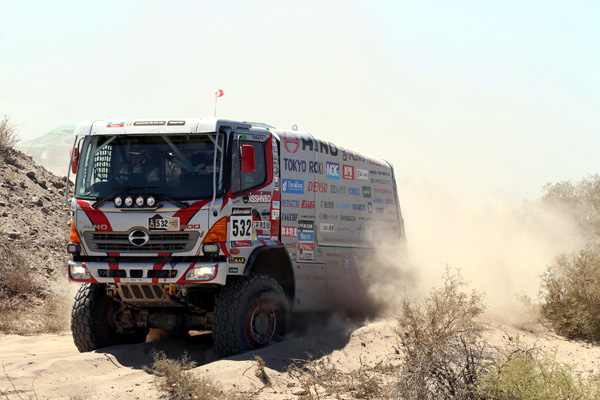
[396,271,492,400]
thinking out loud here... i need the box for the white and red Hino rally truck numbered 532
[67,118,404,356]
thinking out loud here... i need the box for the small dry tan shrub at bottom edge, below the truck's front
[150,352,243,400]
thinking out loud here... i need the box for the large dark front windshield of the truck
[75,133,224,200]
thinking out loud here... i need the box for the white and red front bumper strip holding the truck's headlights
[68,260,227,285]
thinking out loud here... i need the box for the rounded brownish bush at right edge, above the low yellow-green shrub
[541,248,600,342]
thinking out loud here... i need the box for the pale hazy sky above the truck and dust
[0,0,600,199]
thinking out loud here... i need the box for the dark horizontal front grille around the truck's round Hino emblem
[83,231,199,253]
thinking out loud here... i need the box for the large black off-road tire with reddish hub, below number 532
[213,273,290,356]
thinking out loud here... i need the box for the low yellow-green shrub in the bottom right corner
[476,348,600,400]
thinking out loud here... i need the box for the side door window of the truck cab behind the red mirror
[231,140,267,193]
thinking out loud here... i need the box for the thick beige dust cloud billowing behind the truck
[361,179,585,324]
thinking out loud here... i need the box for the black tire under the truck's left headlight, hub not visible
[71,283,148,353]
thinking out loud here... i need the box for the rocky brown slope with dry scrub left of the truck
[0,148,72,333]
